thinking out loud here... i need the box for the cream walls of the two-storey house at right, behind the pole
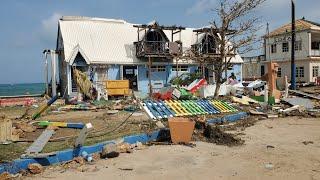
[265,31,320,82]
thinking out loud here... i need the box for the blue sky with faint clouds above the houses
[0,0,320,84]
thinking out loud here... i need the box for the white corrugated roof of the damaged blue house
[59,16,243,64]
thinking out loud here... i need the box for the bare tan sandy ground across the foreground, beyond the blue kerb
[31,117,320,180]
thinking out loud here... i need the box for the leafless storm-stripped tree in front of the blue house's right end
[184,0,266,96]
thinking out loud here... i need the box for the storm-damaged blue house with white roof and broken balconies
[56,16,243,97]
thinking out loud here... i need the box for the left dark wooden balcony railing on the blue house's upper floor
[135,41,182,57]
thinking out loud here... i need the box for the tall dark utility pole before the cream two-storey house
[290,0,296,90]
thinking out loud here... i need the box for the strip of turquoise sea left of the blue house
[0,83,45,96]
